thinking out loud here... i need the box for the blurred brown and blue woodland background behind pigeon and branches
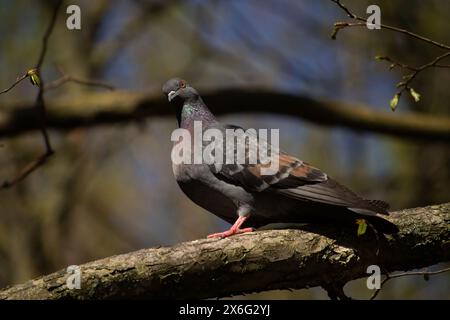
[0,0,450,299]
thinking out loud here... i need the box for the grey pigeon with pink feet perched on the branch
[163,78,398,238]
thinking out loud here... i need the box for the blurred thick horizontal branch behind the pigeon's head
[0,89,450,141]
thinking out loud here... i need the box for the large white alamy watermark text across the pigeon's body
[171,121,279,175]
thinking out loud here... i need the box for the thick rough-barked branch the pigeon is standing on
[0,203,450,299]
